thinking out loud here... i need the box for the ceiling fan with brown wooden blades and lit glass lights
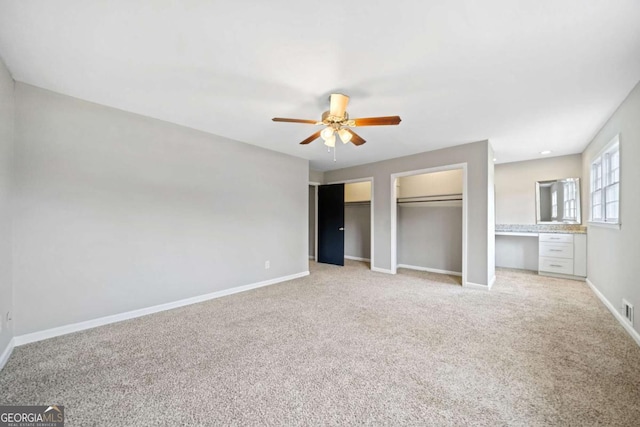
[272,93,401,150]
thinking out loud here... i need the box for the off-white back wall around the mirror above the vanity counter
[495,154,586,224]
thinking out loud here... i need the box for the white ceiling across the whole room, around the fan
[0,0,640,170]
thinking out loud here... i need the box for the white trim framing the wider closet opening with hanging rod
[390,162,469,286]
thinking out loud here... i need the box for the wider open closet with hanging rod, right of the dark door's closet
[391,164,467,285]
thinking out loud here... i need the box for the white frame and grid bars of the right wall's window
[589,134,622,229]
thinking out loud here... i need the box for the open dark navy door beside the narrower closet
[318,184,344,265]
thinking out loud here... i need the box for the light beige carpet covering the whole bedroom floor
[0,262,640,426]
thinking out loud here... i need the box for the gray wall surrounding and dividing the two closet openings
[324,141,495,285]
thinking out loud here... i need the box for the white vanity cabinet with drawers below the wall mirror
[538,233,587,279]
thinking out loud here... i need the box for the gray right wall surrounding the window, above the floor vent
[582,84,640,338]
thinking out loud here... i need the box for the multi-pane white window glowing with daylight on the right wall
[590,135,620,224]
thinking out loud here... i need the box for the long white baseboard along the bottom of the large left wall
[14,271,309,346]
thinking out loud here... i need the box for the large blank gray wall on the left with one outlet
[14,83,309,335]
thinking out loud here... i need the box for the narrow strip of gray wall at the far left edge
[0,61,14,355]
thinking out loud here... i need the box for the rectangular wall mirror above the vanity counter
[536,178,582,224]
